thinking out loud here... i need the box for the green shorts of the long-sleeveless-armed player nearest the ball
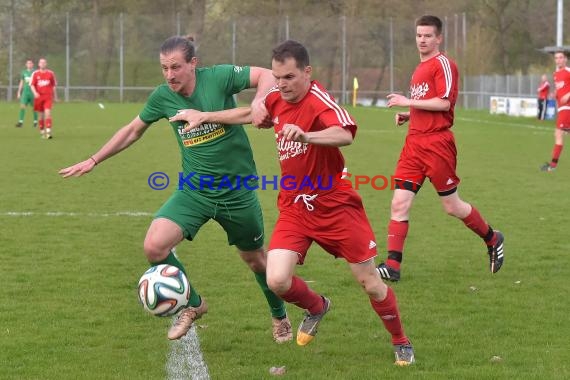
[154,191,264,251]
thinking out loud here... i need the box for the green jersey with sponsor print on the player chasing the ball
[139,65,257,199]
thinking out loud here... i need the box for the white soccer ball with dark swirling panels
[139,264,190,317]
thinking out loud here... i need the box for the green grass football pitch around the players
[0,103,570,380]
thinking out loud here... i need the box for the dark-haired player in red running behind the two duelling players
[378,15,504,281]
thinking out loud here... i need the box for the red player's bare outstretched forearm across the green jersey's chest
[168,107,251,132]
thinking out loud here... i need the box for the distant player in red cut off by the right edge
[540,51,570,172]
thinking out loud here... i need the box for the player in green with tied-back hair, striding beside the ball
[59,36,292,343]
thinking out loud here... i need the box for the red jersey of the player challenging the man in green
[265,81,356,208]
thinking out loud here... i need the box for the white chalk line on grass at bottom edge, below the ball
[166,326,210,380]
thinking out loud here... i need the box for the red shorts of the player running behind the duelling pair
[394,130,460,193]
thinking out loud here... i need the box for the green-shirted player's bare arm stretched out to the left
[59,116,149,178]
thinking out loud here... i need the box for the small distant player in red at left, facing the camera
[30,58,57,139]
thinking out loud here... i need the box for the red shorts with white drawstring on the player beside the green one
[269,189,376,264]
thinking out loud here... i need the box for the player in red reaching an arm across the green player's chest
[171,40,415,366]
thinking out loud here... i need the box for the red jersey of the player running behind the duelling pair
[408,53,459,135]
